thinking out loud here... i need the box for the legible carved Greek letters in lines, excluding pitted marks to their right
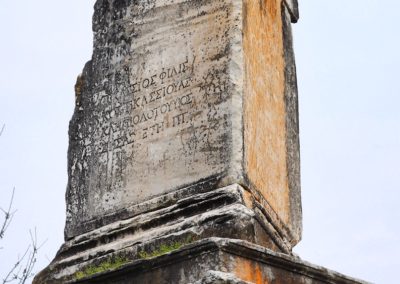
[87,59,198,153]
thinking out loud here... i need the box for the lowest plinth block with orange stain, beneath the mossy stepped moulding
[70,238,366,284]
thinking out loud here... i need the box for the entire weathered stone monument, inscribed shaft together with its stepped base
[35,0,368,283]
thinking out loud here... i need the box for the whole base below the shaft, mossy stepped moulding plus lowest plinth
[34,184,368,284]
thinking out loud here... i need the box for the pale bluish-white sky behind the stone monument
[0,0,400,283]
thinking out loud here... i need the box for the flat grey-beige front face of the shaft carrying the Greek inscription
[66,0,240,235]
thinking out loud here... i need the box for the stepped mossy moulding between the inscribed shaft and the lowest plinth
[35,184,300,283]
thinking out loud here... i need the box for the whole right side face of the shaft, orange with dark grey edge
[243,1,302,244]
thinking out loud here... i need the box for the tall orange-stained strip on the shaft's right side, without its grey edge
[243,0,290,224]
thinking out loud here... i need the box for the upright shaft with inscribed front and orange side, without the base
[65,0,301,250]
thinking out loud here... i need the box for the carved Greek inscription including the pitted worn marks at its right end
[82,55,228,158]
